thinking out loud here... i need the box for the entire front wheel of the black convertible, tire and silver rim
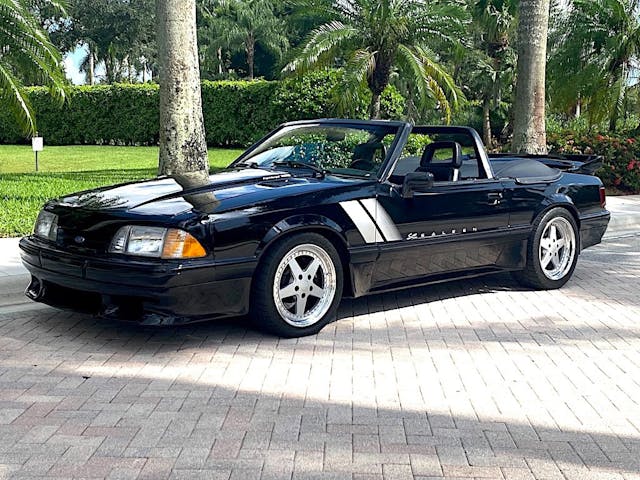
[251,233,343,337]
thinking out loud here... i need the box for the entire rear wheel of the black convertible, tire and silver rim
[514,208,579,290]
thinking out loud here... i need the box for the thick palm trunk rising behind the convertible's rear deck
[512,0,549,154]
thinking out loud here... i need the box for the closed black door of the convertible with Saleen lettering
[372,179,510,289]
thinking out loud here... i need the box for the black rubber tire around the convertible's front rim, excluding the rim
[250,233,344,338]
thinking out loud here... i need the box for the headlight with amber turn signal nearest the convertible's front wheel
[109,226,207,258]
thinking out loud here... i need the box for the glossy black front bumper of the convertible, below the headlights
[20,237,256,325]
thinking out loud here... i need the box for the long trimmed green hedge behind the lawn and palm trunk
[0,72,404,146]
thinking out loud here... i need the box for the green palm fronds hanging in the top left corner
[0,0,66,134]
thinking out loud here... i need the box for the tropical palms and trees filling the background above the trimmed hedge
[0,0,640,149]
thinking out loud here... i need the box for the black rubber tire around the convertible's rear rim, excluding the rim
[513,208,580,290]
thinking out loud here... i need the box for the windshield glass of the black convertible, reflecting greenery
[237,124,398,176]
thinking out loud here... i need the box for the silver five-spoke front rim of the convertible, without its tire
[273,243,336,327]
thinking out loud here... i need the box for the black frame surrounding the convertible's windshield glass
[228,119,411,181]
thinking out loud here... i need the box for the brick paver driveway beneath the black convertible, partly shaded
[0,237,640,480]
